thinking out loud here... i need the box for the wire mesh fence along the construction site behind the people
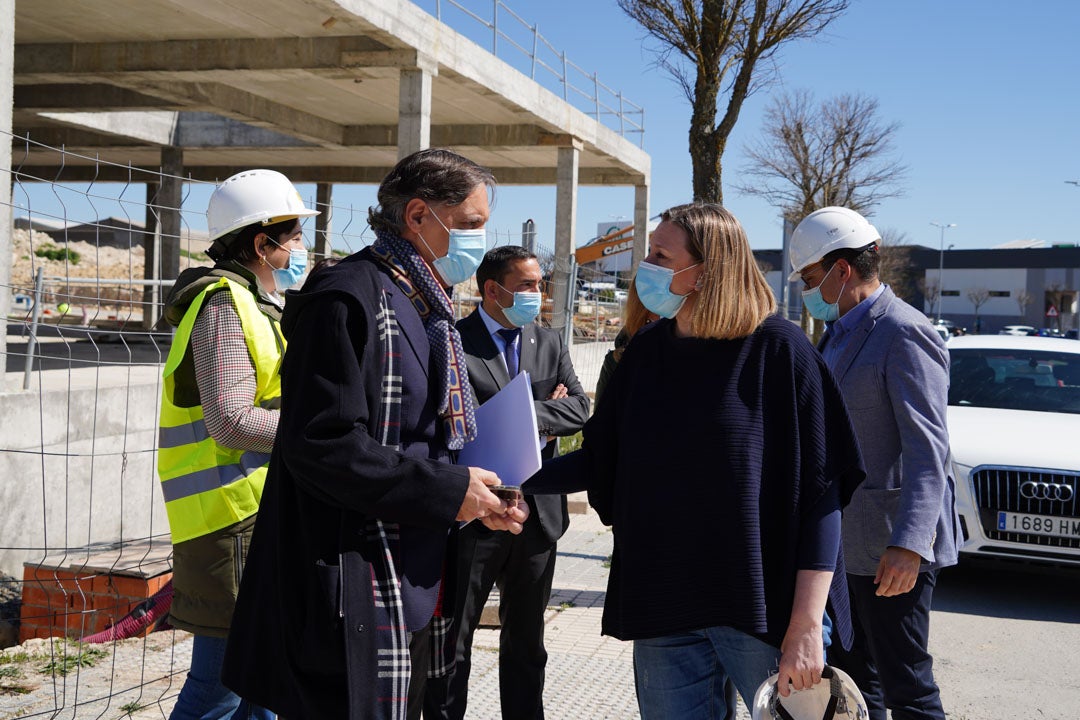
[0,137,621,718]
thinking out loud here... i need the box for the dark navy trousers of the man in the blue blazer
[828,570,945,720]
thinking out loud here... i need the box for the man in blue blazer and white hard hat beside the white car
[789,207,960,720]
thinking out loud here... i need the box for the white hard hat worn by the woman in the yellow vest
[206,169,319,241]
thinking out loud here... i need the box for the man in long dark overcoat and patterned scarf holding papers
[222,148,528,720]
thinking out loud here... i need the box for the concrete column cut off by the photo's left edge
[0,0,15,377]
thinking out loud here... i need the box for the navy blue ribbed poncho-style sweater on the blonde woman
[526,317,863,648]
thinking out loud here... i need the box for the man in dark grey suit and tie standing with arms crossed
[424,245,589,720]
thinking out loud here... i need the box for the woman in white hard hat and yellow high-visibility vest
[158,169,318,720]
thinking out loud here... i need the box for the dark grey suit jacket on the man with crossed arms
[458,309,589,542]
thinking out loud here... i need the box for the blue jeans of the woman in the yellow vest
[168,635,274,720]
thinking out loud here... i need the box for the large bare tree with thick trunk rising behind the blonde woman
[619,0,850,203]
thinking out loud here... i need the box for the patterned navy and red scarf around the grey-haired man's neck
[372,230,476,450]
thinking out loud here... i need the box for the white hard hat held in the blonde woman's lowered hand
[751,665,869,720]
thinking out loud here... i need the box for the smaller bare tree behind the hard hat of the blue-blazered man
[737,91,907,222]
